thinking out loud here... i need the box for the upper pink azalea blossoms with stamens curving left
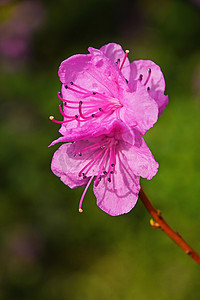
[50,43,168,141]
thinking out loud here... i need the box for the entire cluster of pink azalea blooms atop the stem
[50,43,168,216]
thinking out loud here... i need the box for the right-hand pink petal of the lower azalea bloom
[120,130,159,179]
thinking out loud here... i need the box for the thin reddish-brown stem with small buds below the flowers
[139,188,200,265]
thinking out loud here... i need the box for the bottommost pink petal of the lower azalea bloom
[94,155,140,216]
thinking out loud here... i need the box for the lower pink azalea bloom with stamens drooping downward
[51,121,158,216]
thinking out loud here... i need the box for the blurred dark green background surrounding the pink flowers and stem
[0,0,200,300]
